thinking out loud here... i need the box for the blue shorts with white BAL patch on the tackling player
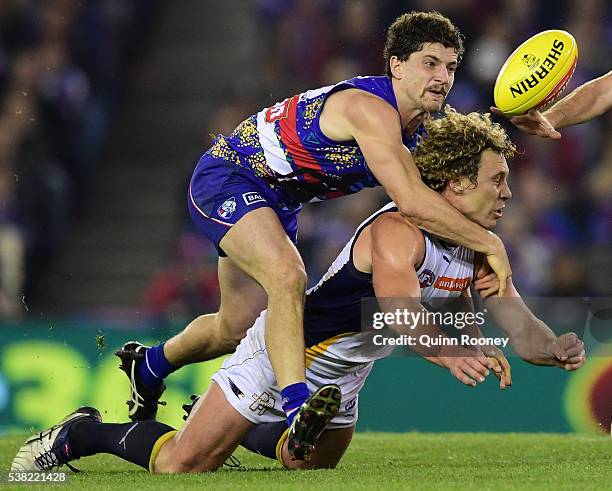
[187,153,301,256]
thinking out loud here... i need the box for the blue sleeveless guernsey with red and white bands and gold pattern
[207,76,426,208]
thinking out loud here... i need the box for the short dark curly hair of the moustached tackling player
[383,12,464,77]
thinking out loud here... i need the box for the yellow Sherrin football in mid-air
[493,30,578,116]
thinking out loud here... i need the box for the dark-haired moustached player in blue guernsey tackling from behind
[113,12,511,462]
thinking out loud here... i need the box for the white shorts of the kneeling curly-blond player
[212,311,373,429]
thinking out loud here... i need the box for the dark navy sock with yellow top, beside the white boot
[68,420,174,470]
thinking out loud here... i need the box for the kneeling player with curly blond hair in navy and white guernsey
[11,109,585,473]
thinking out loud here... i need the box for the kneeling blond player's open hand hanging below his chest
[436,346,495,387]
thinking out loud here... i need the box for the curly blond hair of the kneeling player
[413,105,516,191]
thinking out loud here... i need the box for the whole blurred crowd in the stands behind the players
[0,0,612,316]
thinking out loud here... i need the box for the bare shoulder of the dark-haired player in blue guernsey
[319,89,401,141]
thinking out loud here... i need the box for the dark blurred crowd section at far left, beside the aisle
[0,0,157,315]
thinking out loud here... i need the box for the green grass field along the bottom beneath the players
[0,433,612,491]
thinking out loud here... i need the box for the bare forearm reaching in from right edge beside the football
[543,72,612,129]
